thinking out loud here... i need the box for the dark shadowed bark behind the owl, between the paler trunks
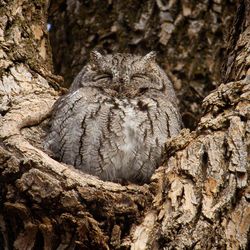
[49,0,237,129]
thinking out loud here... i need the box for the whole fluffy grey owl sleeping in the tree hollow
[46,51,181,183]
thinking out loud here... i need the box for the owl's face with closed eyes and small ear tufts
[82,51,165,96]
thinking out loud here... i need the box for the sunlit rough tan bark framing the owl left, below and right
[0,0,250,250]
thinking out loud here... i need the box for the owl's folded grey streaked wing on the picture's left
[45,88,100,165]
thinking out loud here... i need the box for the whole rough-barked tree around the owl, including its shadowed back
[0,0,250,250]
